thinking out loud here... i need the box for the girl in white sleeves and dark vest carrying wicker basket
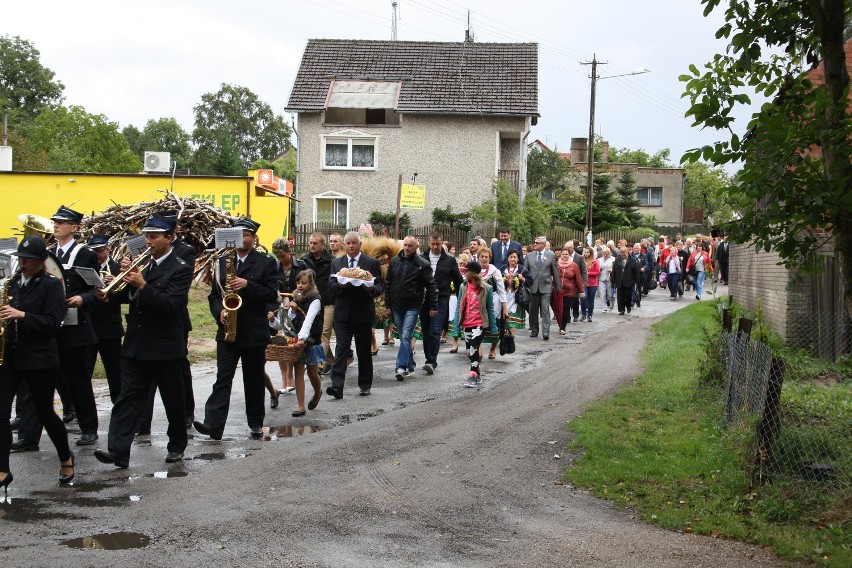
[290,269,325,417]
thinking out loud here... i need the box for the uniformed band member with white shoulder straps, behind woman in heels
[18,205,100,446]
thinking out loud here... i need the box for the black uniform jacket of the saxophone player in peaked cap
[207,249,278,347]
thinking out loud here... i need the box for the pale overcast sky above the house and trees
[0,0,746,162]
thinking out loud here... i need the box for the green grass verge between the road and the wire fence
[565,302,852,566]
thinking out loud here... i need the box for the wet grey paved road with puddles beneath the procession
[0,291,792,567]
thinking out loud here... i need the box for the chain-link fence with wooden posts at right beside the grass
[719,310,852,491]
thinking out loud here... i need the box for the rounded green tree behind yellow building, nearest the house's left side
[192,83,290,175]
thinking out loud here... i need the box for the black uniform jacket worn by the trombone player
[118,248,192,361]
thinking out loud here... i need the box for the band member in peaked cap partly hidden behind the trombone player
[86,235,124,404]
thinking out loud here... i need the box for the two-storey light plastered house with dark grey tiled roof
[287,39,539,227]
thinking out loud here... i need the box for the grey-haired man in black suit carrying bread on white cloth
[325,231,384,398]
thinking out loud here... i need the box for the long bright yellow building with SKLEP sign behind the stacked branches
[0,170,292,247]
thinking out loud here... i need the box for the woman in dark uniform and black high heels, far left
[0,236,74,494]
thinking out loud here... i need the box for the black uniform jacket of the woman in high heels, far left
[5,272,65,371]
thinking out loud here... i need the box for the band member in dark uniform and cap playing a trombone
[95,213,193,467]
